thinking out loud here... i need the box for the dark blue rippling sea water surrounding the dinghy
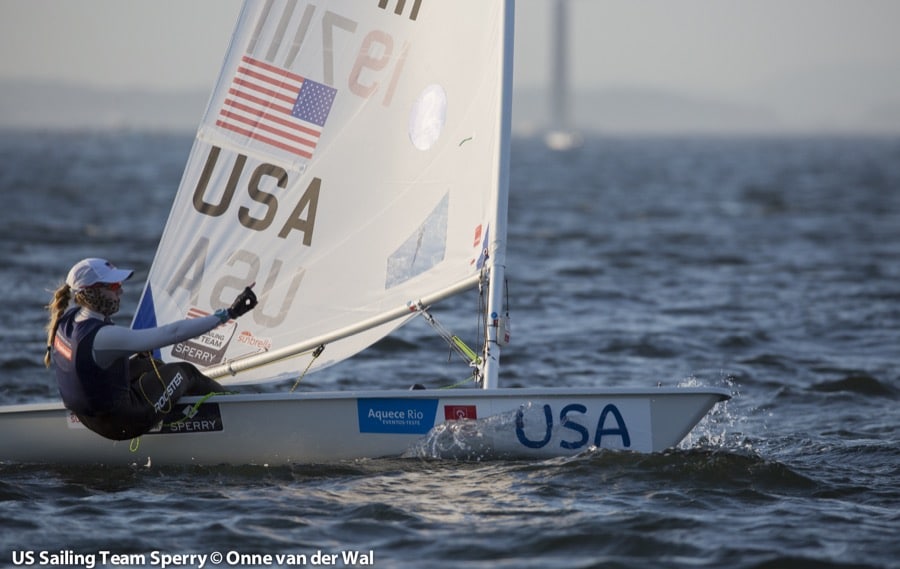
[0,132,900,569]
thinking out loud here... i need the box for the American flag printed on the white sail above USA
[216,55,337,158]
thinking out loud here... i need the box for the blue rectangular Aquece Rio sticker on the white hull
[356,398,438,435]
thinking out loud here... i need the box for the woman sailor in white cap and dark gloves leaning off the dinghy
[44,258,257,440]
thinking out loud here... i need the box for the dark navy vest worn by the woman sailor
[53,308,130,417]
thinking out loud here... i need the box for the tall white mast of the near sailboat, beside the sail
[482,0,515,389]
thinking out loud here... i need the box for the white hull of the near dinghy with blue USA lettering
[0,388,729,466]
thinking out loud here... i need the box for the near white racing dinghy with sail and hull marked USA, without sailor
[0,0,729,465]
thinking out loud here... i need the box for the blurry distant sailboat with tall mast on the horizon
[544,0,584,151]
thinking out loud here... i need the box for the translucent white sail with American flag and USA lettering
[133,0,512,383]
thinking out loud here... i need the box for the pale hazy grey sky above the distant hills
[0,0,900,129]
